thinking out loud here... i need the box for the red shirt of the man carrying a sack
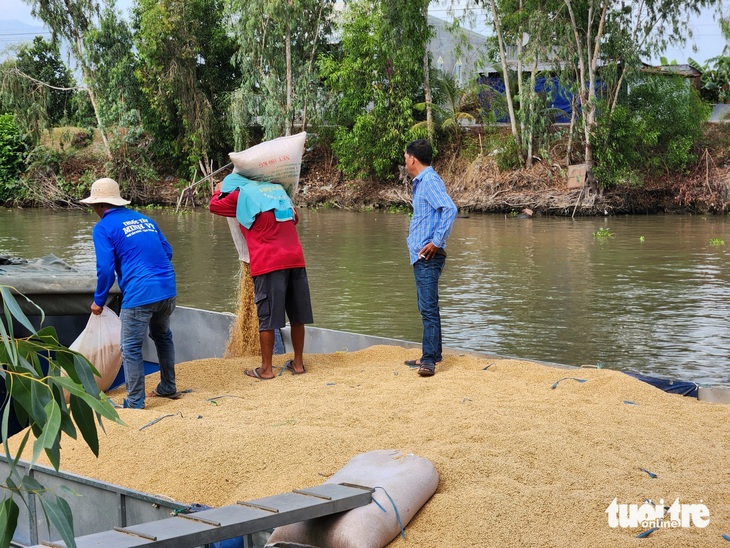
[210,190,305,276]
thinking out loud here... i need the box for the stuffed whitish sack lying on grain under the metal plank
[267,450,439,548]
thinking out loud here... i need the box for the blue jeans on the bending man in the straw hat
[119,297,177,409]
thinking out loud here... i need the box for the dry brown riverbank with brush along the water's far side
[17,124,730,217]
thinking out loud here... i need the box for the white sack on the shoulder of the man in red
[228,131,307,198]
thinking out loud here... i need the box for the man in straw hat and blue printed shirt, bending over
[81,178,178,409]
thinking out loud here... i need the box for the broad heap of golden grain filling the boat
[7,346,730,547]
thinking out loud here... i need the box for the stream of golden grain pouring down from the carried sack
[224,261,261,358]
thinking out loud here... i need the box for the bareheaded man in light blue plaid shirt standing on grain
[404,139,457,377]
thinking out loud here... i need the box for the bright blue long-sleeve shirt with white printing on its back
[92,206,177,308]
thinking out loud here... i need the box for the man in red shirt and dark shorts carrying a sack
[210,177,314,380]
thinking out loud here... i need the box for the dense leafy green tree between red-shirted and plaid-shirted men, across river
[320,0,430,179]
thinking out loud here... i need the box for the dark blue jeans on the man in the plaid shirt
[413,255,446,364]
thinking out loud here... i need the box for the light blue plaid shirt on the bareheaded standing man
[406,166,457,264]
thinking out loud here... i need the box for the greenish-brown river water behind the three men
[0,209,730,385]
